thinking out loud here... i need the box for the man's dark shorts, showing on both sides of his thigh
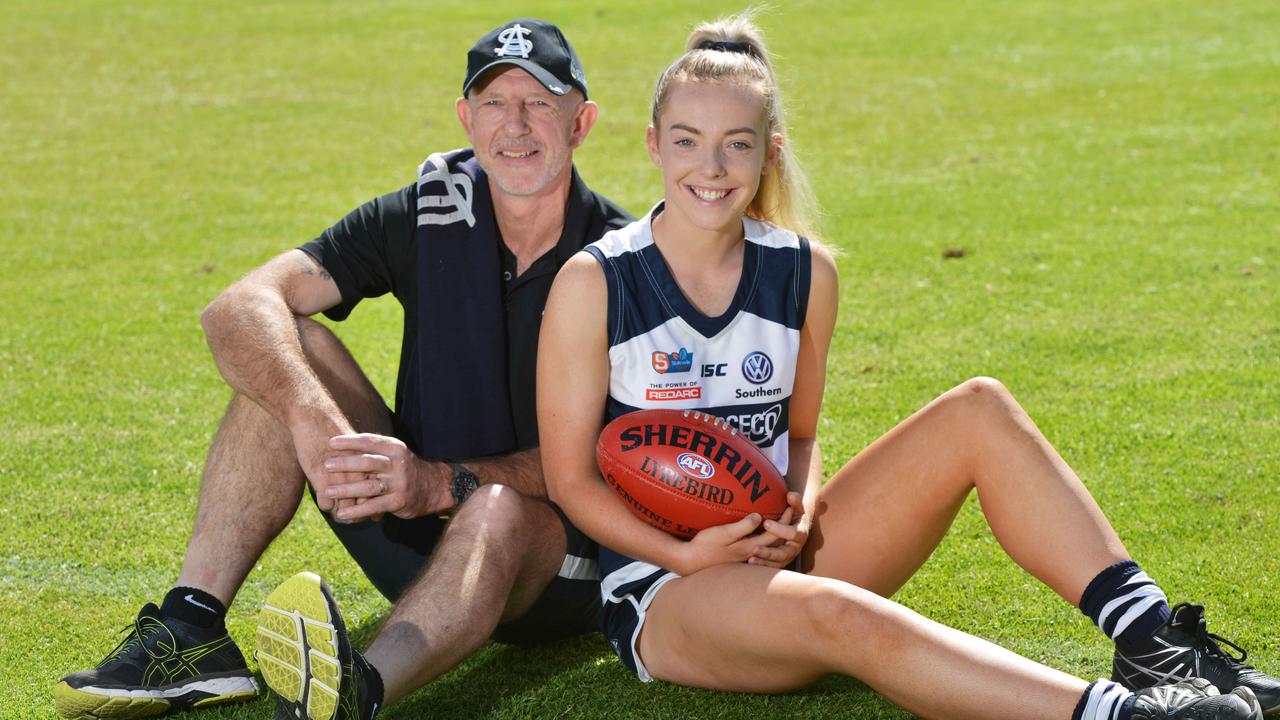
[311,427,600,644]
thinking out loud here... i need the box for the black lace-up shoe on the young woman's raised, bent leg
[1111,602,1280,715]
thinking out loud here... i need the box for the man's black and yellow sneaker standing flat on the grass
[54,602,259,717]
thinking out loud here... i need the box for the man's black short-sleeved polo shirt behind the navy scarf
[301,169,634,450]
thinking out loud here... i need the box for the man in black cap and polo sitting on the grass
[54,19,630,717]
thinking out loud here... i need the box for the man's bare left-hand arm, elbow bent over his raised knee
[200,250,352,510]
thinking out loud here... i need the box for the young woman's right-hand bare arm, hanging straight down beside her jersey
[751,246,840,568]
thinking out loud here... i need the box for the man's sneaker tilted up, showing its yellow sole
[256,573,381,720]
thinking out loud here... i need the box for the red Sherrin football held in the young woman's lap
[595,410,787,538]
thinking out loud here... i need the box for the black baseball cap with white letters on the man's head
[462,18,586,97]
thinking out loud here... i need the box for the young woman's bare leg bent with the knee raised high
[804,378,1129,605]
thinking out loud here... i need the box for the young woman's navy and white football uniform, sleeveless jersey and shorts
[586,205,810,680]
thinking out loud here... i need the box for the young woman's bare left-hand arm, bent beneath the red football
[538,252,772,575]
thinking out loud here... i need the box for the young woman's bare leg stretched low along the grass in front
[639,565,1088,720]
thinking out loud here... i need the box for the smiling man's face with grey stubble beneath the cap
[457,67,595,196]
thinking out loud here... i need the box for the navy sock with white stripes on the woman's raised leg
[1080,560,1169,644]
